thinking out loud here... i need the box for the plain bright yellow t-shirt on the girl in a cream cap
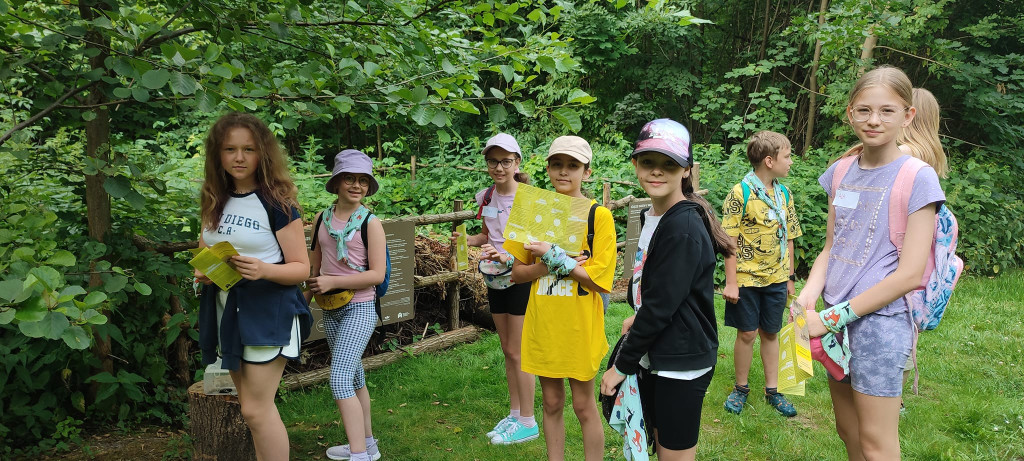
[504,203,615,381]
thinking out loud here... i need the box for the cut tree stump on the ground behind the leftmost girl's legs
[188,381,256,461]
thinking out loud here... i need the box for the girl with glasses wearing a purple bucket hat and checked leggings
[306,149,387,461]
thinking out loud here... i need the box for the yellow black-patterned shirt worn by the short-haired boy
[722,184,804,287]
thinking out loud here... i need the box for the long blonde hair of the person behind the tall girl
[897,88,949,177]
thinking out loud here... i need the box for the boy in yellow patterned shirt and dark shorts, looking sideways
[722,131,803,417]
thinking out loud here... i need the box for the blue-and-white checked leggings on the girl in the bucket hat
[324,300,377,400]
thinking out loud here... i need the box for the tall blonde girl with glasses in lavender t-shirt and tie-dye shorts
[797,67,945,460]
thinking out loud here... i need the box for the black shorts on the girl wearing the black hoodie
[640,368,715,450]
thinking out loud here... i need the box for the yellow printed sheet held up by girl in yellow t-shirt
[504,184,590,256]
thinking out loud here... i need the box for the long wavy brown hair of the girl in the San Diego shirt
[200,112,301,231]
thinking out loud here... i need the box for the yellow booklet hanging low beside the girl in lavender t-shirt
[778,296,814,395]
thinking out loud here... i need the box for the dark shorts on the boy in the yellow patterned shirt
[725,282,790,334]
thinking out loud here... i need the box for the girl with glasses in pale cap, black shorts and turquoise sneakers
[452,133,540,445]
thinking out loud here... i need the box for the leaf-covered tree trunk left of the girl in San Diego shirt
[79,1,114,397]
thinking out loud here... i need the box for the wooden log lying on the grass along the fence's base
[280,325,484,391]
